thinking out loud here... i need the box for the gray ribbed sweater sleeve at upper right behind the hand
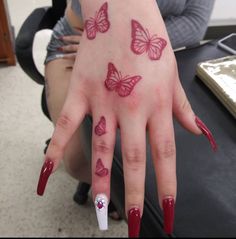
[164,0,214,48]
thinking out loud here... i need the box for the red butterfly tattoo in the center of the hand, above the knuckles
[105,63,142,97]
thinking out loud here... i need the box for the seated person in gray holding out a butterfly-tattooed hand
[37,0,216,237]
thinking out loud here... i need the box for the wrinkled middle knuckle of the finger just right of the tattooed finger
[124,147,144,171]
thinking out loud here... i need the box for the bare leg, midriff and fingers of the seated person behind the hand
[45,0,91,183]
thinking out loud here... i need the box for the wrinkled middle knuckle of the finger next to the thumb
[156,140,176,159]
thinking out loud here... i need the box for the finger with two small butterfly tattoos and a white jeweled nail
[92,110,116,230]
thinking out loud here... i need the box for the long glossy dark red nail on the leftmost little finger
[37,159,54,196]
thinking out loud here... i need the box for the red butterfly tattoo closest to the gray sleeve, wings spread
[131,20,167,60]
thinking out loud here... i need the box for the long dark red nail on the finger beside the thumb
[162,197,175,235]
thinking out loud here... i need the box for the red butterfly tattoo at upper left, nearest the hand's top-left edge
[85,2,110,40]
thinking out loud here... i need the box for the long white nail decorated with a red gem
[94,194,108,231]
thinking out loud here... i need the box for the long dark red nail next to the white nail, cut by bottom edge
[128,208,141,237]
